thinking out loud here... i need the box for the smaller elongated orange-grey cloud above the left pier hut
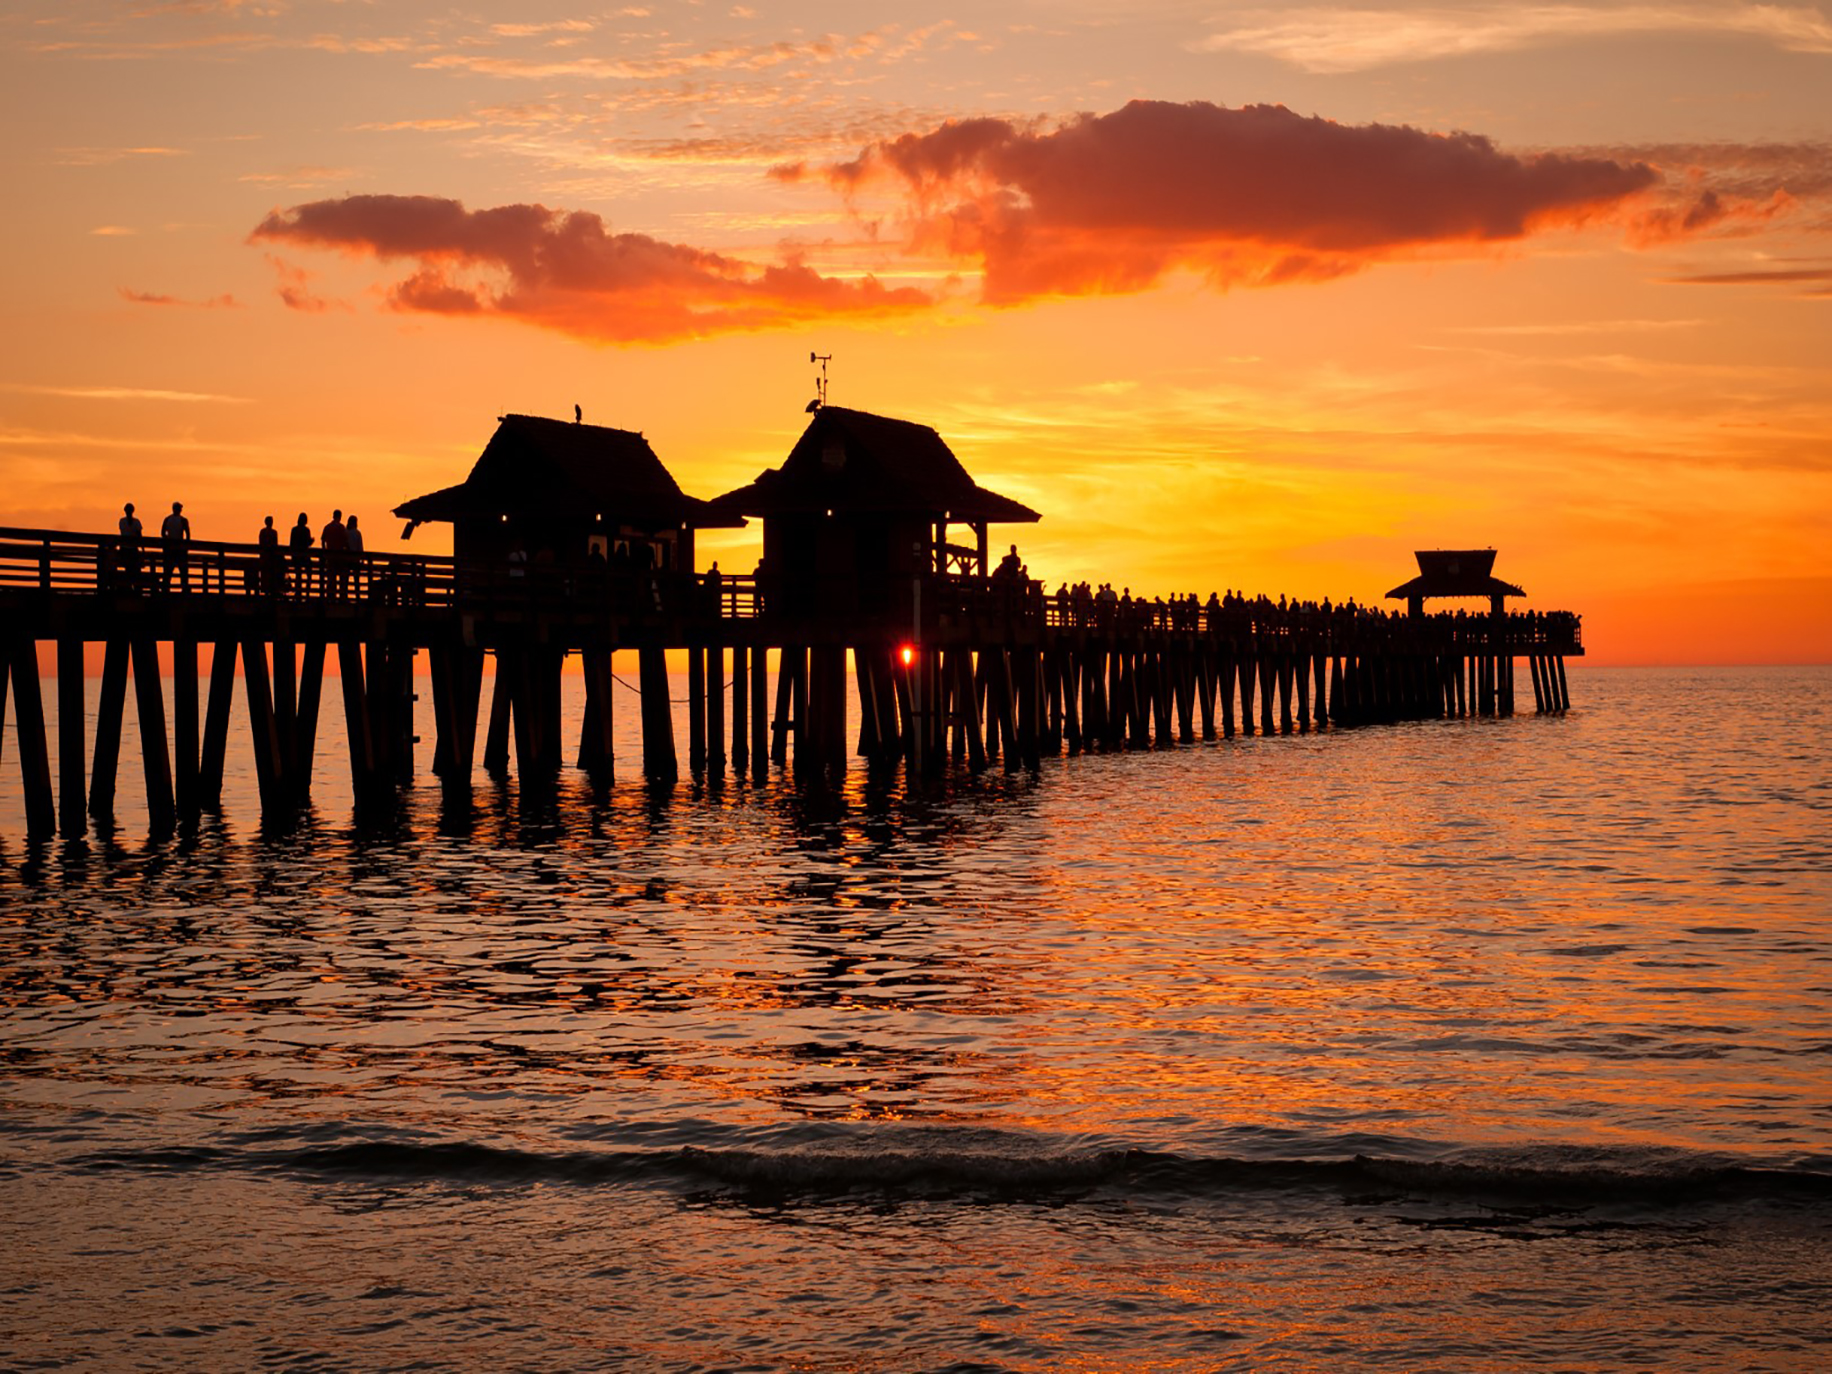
[251,196,932,343]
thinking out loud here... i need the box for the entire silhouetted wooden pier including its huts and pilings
[0,403,1583,835]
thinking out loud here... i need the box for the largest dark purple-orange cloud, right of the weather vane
[824,101,1660,302]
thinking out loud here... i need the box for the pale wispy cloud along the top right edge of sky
[1191,4,1832,73]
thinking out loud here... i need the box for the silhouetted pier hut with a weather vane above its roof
[713,405,1042,612]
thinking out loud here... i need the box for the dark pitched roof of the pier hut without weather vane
[394,416,744,528]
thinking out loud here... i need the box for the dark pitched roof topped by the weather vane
[713,405,1042,522]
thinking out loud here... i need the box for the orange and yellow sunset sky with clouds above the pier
[0,0,1832,663]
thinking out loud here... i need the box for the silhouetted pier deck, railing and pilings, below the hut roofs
[0,529,1583,834]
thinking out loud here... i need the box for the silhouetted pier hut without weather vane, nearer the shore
[394,416,744,572]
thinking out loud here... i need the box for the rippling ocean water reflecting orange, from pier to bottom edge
[0,669,1832,1372]
